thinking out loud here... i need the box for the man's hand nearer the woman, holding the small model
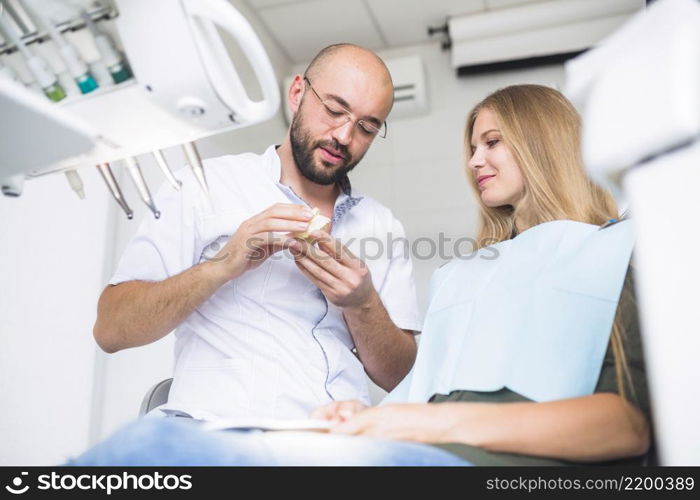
[292,231,376,308]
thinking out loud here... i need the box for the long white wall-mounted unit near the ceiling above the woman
[448,0,645,76]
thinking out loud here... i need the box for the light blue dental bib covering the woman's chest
[382,220,633,404]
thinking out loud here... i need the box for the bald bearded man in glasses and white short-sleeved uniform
[94,44,421,420]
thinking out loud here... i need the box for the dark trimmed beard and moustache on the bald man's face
[289,109,364,186]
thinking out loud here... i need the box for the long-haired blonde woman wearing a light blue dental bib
[316,85,651,465]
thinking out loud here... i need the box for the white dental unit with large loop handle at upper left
[0,0,280,203]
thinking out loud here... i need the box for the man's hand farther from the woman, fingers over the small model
[211,203,313,280]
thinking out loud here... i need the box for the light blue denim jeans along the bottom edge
[66,418,470,466]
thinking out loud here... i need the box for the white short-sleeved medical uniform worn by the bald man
[110,146,421,418]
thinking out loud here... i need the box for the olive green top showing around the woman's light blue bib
[430,266,651,466]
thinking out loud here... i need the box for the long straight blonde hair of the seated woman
[465,85,634,406]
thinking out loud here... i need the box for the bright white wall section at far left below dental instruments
[0,168,112,465]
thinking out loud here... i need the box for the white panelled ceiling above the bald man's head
[246,0,542,63]
